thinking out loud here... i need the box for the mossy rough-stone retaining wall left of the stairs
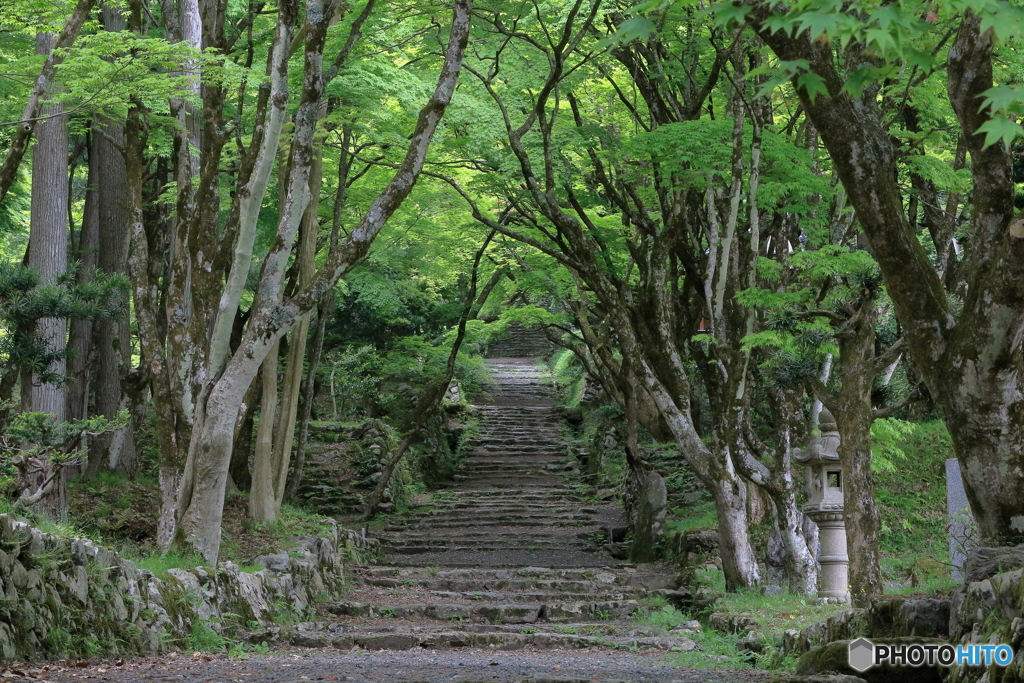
[0,515,373,661]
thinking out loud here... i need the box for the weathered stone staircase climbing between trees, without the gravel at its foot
[292,358,696,650]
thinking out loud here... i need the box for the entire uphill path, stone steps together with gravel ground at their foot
[41,348,768,683]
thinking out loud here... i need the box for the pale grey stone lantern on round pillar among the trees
[794,408,850,604]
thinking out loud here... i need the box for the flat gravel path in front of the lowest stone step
[32,650,772,683]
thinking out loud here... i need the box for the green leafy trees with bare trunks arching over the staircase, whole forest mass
[0,0,1024,614]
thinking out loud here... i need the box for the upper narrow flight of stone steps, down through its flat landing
[377,358,625,575]
